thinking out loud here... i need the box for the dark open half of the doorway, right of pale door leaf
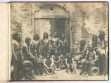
[50,18,70,49]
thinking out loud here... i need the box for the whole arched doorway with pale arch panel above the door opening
[34,4,70,43]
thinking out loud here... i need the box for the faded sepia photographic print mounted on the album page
[10,2,109,81]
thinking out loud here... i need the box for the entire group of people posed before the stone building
[11,32,107,80]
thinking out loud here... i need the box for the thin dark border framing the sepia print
[8,0,110,82]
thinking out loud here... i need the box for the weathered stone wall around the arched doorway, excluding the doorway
[11,2,108,48]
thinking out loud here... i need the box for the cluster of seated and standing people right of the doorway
[75,32,108,76]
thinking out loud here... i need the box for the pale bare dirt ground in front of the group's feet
[36,70,108,80]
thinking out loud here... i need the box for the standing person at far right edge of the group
[98,31,108,75]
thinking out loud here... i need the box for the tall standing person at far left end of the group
[11,32,23,80]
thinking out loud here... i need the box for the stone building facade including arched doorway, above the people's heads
[11,2,108,53]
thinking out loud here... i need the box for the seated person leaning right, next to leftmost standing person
[22,37,37,74]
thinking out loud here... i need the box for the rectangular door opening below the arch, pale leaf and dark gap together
[34,18,70,48]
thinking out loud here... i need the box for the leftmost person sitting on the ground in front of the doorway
[44,54,54,75]
